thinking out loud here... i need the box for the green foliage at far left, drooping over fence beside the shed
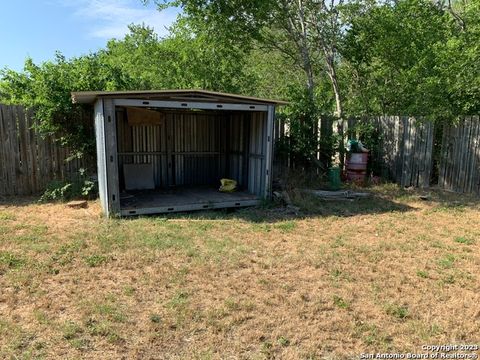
[0,53,130,156]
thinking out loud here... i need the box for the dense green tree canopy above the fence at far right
[342,0,480,120]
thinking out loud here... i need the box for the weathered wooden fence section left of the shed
[0,104,89,196]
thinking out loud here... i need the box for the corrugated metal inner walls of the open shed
[116,109,267,196]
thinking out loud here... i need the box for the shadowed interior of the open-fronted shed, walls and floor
[115,106,268,215]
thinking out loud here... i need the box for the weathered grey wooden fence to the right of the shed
[275,116,480,194]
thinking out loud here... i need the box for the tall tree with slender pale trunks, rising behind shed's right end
[153,0,352,167]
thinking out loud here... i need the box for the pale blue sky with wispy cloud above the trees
[0,0,179,71]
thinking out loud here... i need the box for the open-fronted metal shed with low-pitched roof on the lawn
[72,90,285,216]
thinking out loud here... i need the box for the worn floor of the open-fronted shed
[120,187,259,216]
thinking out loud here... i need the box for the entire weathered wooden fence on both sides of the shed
[0,104,480,196]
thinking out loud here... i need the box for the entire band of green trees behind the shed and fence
[0,0,480,163]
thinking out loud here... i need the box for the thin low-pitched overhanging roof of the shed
[71,89,288,105]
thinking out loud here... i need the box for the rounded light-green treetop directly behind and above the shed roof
[99,19,253,93]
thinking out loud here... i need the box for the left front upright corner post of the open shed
[103,99,120,216]
